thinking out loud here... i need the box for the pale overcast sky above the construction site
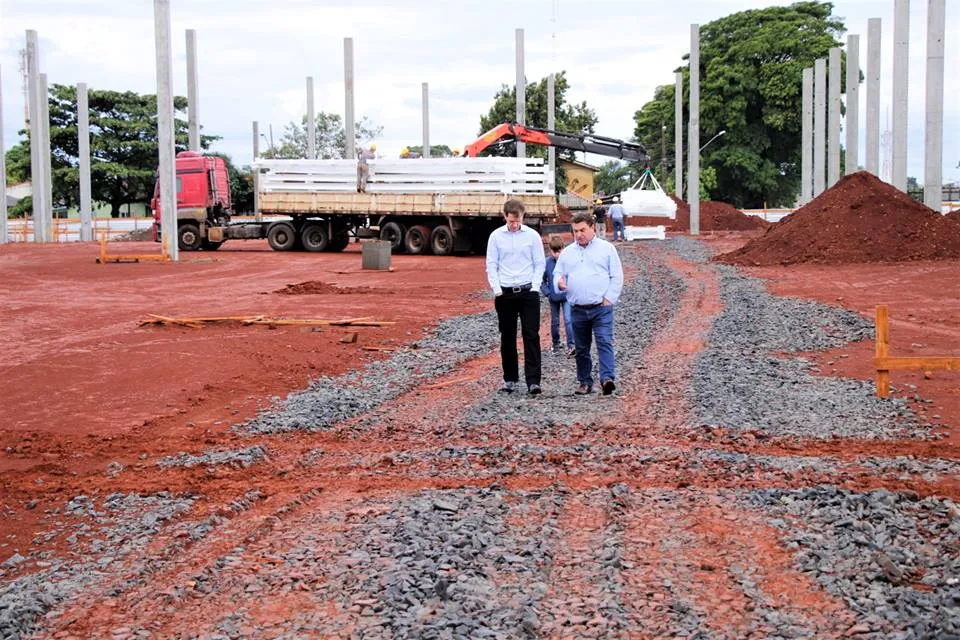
[0,0,960,182]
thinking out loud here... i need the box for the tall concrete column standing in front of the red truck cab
[153,0,180,261]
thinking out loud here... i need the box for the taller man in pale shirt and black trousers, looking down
[487,200,546,395]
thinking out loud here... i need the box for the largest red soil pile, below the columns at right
[714,171,960,266]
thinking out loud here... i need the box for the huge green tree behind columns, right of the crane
[634,1,844,208]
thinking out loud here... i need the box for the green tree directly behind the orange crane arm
[478,71,597,191]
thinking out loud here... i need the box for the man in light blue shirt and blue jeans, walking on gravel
[553,213,623,396]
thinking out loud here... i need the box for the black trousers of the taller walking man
[493,291,540,385]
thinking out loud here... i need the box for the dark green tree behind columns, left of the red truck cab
[7,84,219,218]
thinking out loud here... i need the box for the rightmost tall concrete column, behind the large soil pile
[923,0,946,211]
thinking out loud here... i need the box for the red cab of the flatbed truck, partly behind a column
[150,151,231,251]
